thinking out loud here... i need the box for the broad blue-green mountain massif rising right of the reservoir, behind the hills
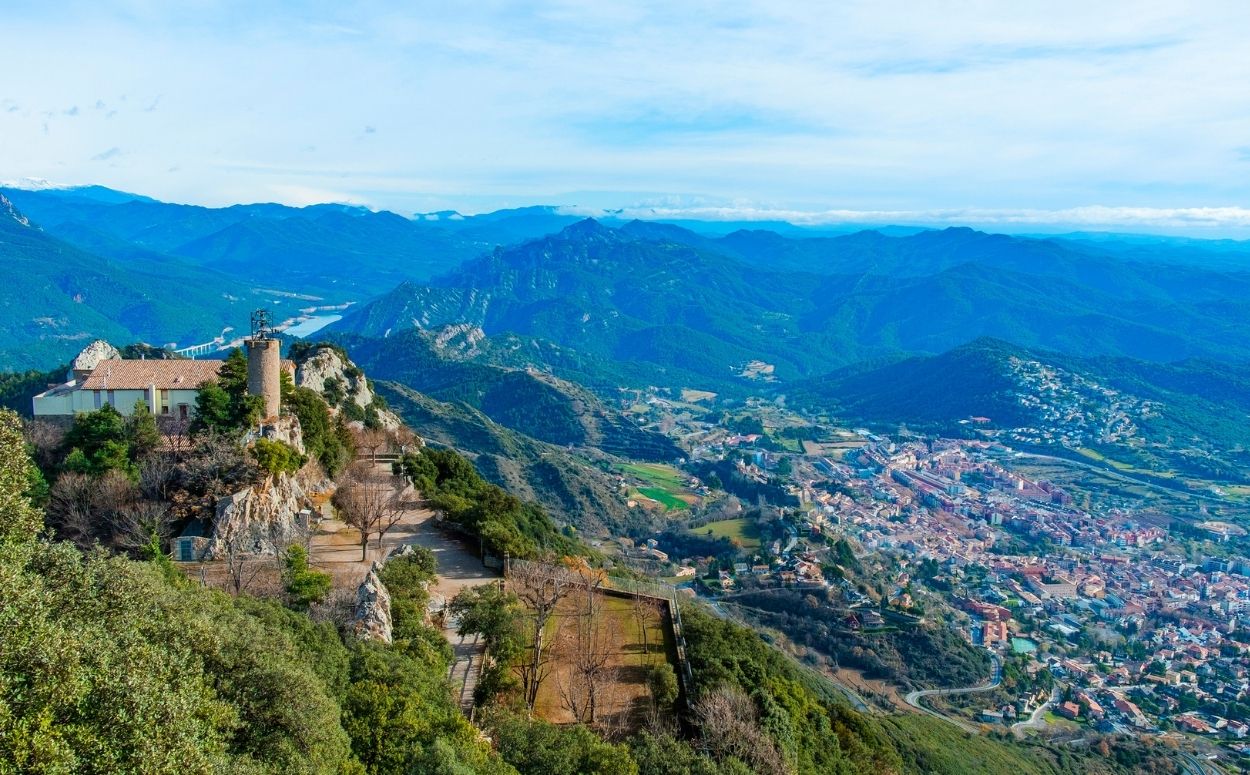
[334,220,1250,385]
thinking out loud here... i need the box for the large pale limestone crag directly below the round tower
[205,474,311,560]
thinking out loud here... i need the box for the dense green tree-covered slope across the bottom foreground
[0,411,1169,775]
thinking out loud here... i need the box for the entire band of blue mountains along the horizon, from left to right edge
[7,186,1250,377]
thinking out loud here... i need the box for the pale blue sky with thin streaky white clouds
[0,0,1250,239]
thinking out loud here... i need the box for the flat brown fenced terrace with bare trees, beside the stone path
[535,593,676,733]
